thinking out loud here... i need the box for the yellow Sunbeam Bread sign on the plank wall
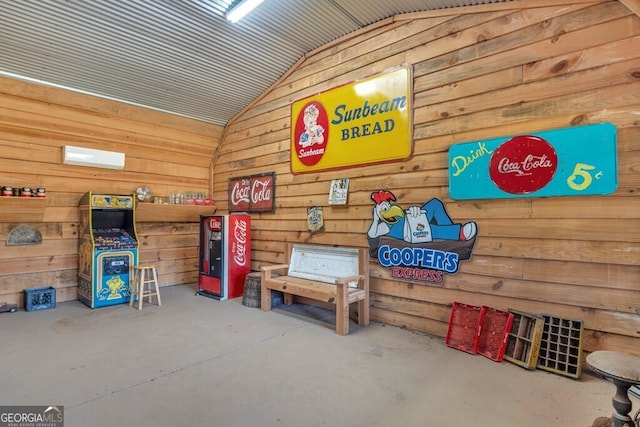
[291,66,413,173]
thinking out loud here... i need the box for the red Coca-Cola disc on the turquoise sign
[489,135,558,194]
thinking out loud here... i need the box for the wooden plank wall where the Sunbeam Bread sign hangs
[213,0,640,355]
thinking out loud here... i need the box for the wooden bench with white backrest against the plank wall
[260,243,369,335]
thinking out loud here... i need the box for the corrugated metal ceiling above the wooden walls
[0,0,509,125]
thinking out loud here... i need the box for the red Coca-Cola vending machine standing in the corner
[197,214,251,300]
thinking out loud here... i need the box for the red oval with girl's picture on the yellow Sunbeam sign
[293,101,329,166]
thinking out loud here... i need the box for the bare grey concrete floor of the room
[0,285,638,427]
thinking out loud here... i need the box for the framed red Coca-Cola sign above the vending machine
[229,172,276,212]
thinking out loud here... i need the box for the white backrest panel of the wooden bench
[287,244,362,287]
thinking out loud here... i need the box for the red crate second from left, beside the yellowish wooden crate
[478,306,513,362]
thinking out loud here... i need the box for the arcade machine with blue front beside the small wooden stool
[78,192,138,308]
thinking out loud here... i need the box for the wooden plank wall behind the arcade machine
[0,77,223,306]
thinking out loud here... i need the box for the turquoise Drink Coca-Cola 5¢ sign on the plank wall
[449,123,618,199]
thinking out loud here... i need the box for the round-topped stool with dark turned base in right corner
[587,351,640,427]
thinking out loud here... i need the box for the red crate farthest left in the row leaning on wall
[445,302,484,354]
